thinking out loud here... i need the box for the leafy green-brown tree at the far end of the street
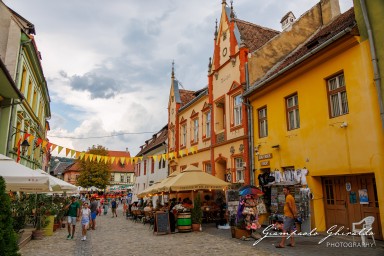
[77,145,111,189]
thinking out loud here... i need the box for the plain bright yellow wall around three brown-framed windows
[251,38,384,234]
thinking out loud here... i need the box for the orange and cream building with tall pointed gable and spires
[168,1,279,184]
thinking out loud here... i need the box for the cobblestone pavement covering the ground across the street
[20,210,384,256]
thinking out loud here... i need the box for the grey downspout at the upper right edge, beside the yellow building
[360,0,384,130]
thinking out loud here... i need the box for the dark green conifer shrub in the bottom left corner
[0,176,19,256]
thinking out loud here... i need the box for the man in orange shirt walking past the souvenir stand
[276,187,297,248]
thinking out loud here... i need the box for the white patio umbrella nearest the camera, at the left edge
[0,154,51,193]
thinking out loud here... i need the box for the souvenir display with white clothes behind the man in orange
[258,168,312,232]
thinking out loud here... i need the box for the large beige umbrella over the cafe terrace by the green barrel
[161,166,230,192]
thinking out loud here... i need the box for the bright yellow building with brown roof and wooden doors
[244,5,384,239]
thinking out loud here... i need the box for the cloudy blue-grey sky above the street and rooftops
[3,0,353,156]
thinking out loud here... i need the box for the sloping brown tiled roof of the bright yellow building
[245,8,357,92]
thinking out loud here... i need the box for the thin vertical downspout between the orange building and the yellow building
[244,62,255,185]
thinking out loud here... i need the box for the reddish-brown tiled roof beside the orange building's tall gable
[236,19,280,52]
